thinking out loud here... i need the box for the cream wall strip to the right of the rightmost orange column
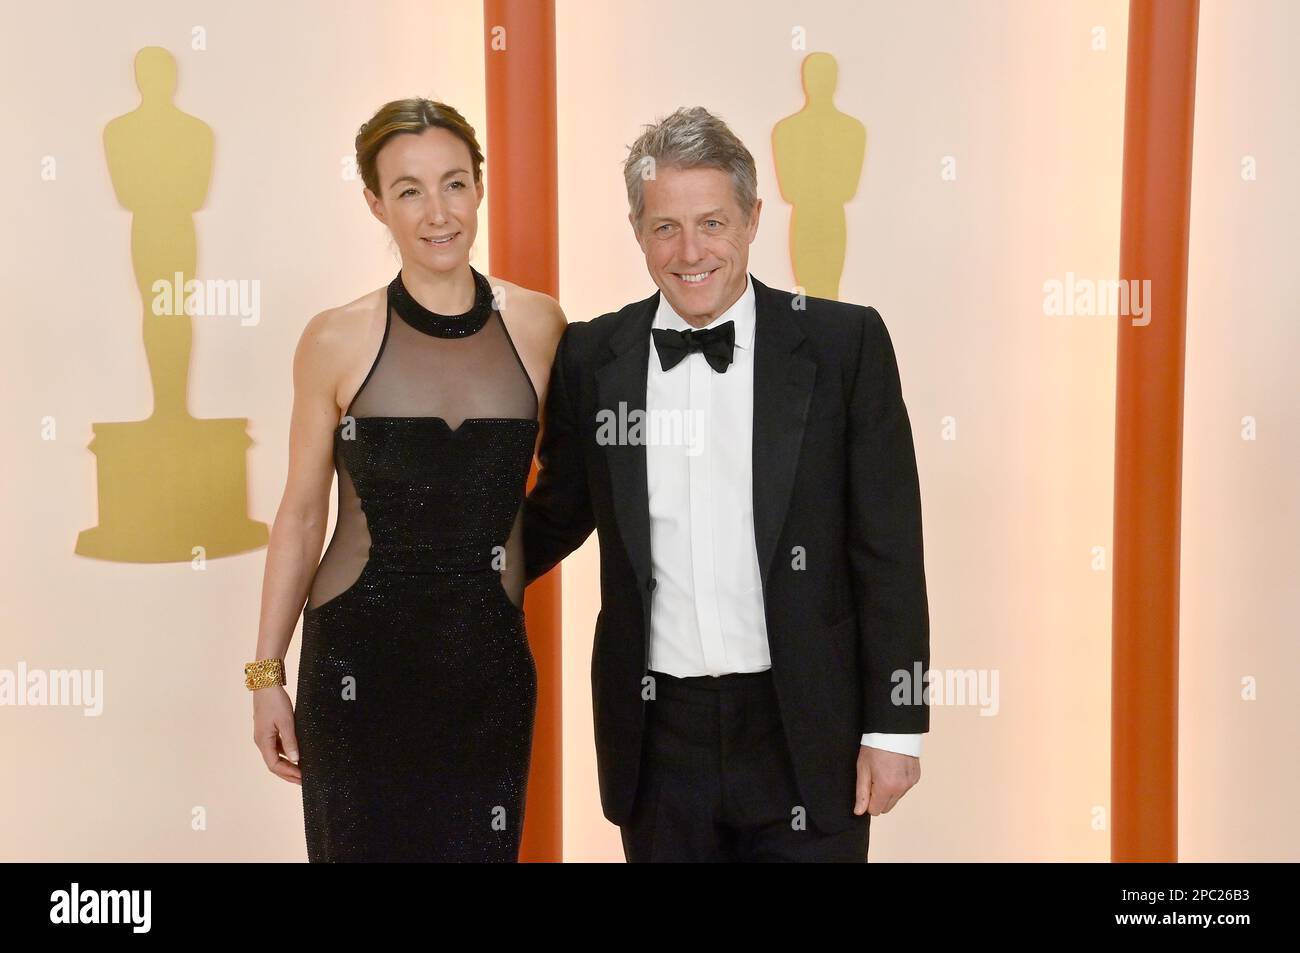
[1178,0,1300,861]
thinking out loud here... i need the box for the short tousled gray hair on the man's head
[623,105,758,231]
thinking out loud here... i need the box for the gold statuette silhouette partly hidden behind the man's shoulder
[772,53,867,300]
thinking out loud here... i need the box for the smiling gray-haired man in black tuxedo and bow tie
[524,107,930,862]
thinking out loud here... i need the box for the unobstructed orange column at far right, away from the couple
[1110,0,1199,861]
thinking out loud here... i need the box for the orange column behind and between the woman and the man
[484,0,563,862]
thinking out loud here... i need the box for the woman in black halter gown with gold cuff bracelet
[250,100,564,861]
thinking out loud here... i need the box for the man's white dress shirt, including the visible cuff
[644,274,920,758]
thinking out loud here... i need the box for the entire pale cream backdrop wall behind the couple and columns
[0,0,1300,861]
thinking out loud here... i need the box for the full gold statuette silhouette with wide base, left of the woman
[75,47,268,563]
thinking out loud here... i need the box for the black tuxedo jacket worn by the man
[524,269,930,832]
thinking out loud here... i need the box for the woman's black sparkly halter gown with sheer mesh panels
[295,263,538,862]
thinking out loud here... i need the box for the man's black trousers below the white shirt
[620,670,871,863]
